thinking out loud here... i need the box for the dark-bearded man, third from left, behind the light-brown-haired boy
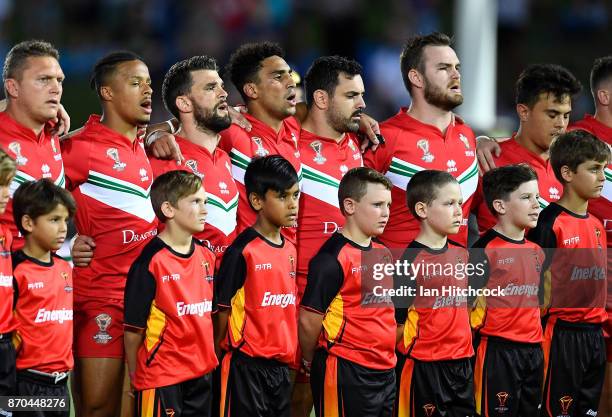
[151,56,238,266]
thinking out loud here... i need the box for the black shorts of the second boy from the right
[474,336,544,417]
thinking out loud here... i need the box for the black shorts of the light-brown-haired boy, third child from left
[134,373,212,417]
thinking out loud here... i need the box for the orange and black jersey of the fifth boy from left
[301,233,396,369]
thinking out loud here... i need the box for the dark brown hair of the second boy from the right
[482,164,538,216]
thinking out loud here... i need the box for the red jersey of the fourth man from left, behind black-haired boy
[219,113,302,244]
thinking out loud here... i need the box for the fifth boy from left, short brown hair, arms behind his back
[299,168,396,417]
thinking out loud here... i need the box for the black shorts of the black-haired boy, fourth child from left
[219,350,291,417]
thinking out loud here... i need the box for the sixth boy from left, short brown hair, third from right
[395,170,474,417]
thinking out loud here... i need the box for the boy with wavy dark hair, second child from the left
[13,179,76,416]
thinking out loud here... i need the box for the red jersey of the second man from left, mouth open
[62,115,157,300]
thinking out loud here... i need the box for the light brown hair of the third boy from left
[151,171,202,223]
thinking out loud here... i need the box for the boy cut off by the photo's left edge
[0,149,16,415]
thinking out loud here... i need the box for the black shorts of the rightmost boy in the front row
[542,320,606,417]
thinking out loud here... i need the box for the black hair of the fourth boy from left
[244,155,298,206]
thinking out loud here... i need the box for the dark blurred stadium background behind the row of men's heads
[0,0,612,135]
